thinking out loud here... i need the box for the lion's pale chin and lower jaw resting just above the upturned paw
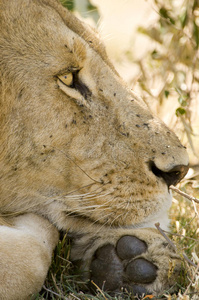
[42,193,172,232]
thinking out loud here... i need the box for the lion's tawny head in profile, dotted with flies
[0,0,188,228]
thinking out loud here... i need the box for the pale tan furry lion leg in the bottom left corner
[0,214,59,300]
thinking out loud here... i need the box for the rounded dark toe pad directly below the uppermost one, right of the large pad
[126,258,157,283]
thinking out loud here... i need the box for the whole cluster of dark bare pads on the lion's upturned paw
[91,236,157,296]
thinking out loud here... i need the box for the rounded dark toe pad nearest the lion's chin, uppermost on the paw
[116,235,147,259]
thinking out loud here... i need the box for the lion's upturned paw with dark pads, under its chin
[71,228,181,296]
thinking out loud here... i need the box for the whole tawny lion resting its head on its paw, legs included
[0,0,188,300]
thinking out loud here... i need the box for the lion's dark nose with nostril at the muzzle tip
[151,162,189,187]
